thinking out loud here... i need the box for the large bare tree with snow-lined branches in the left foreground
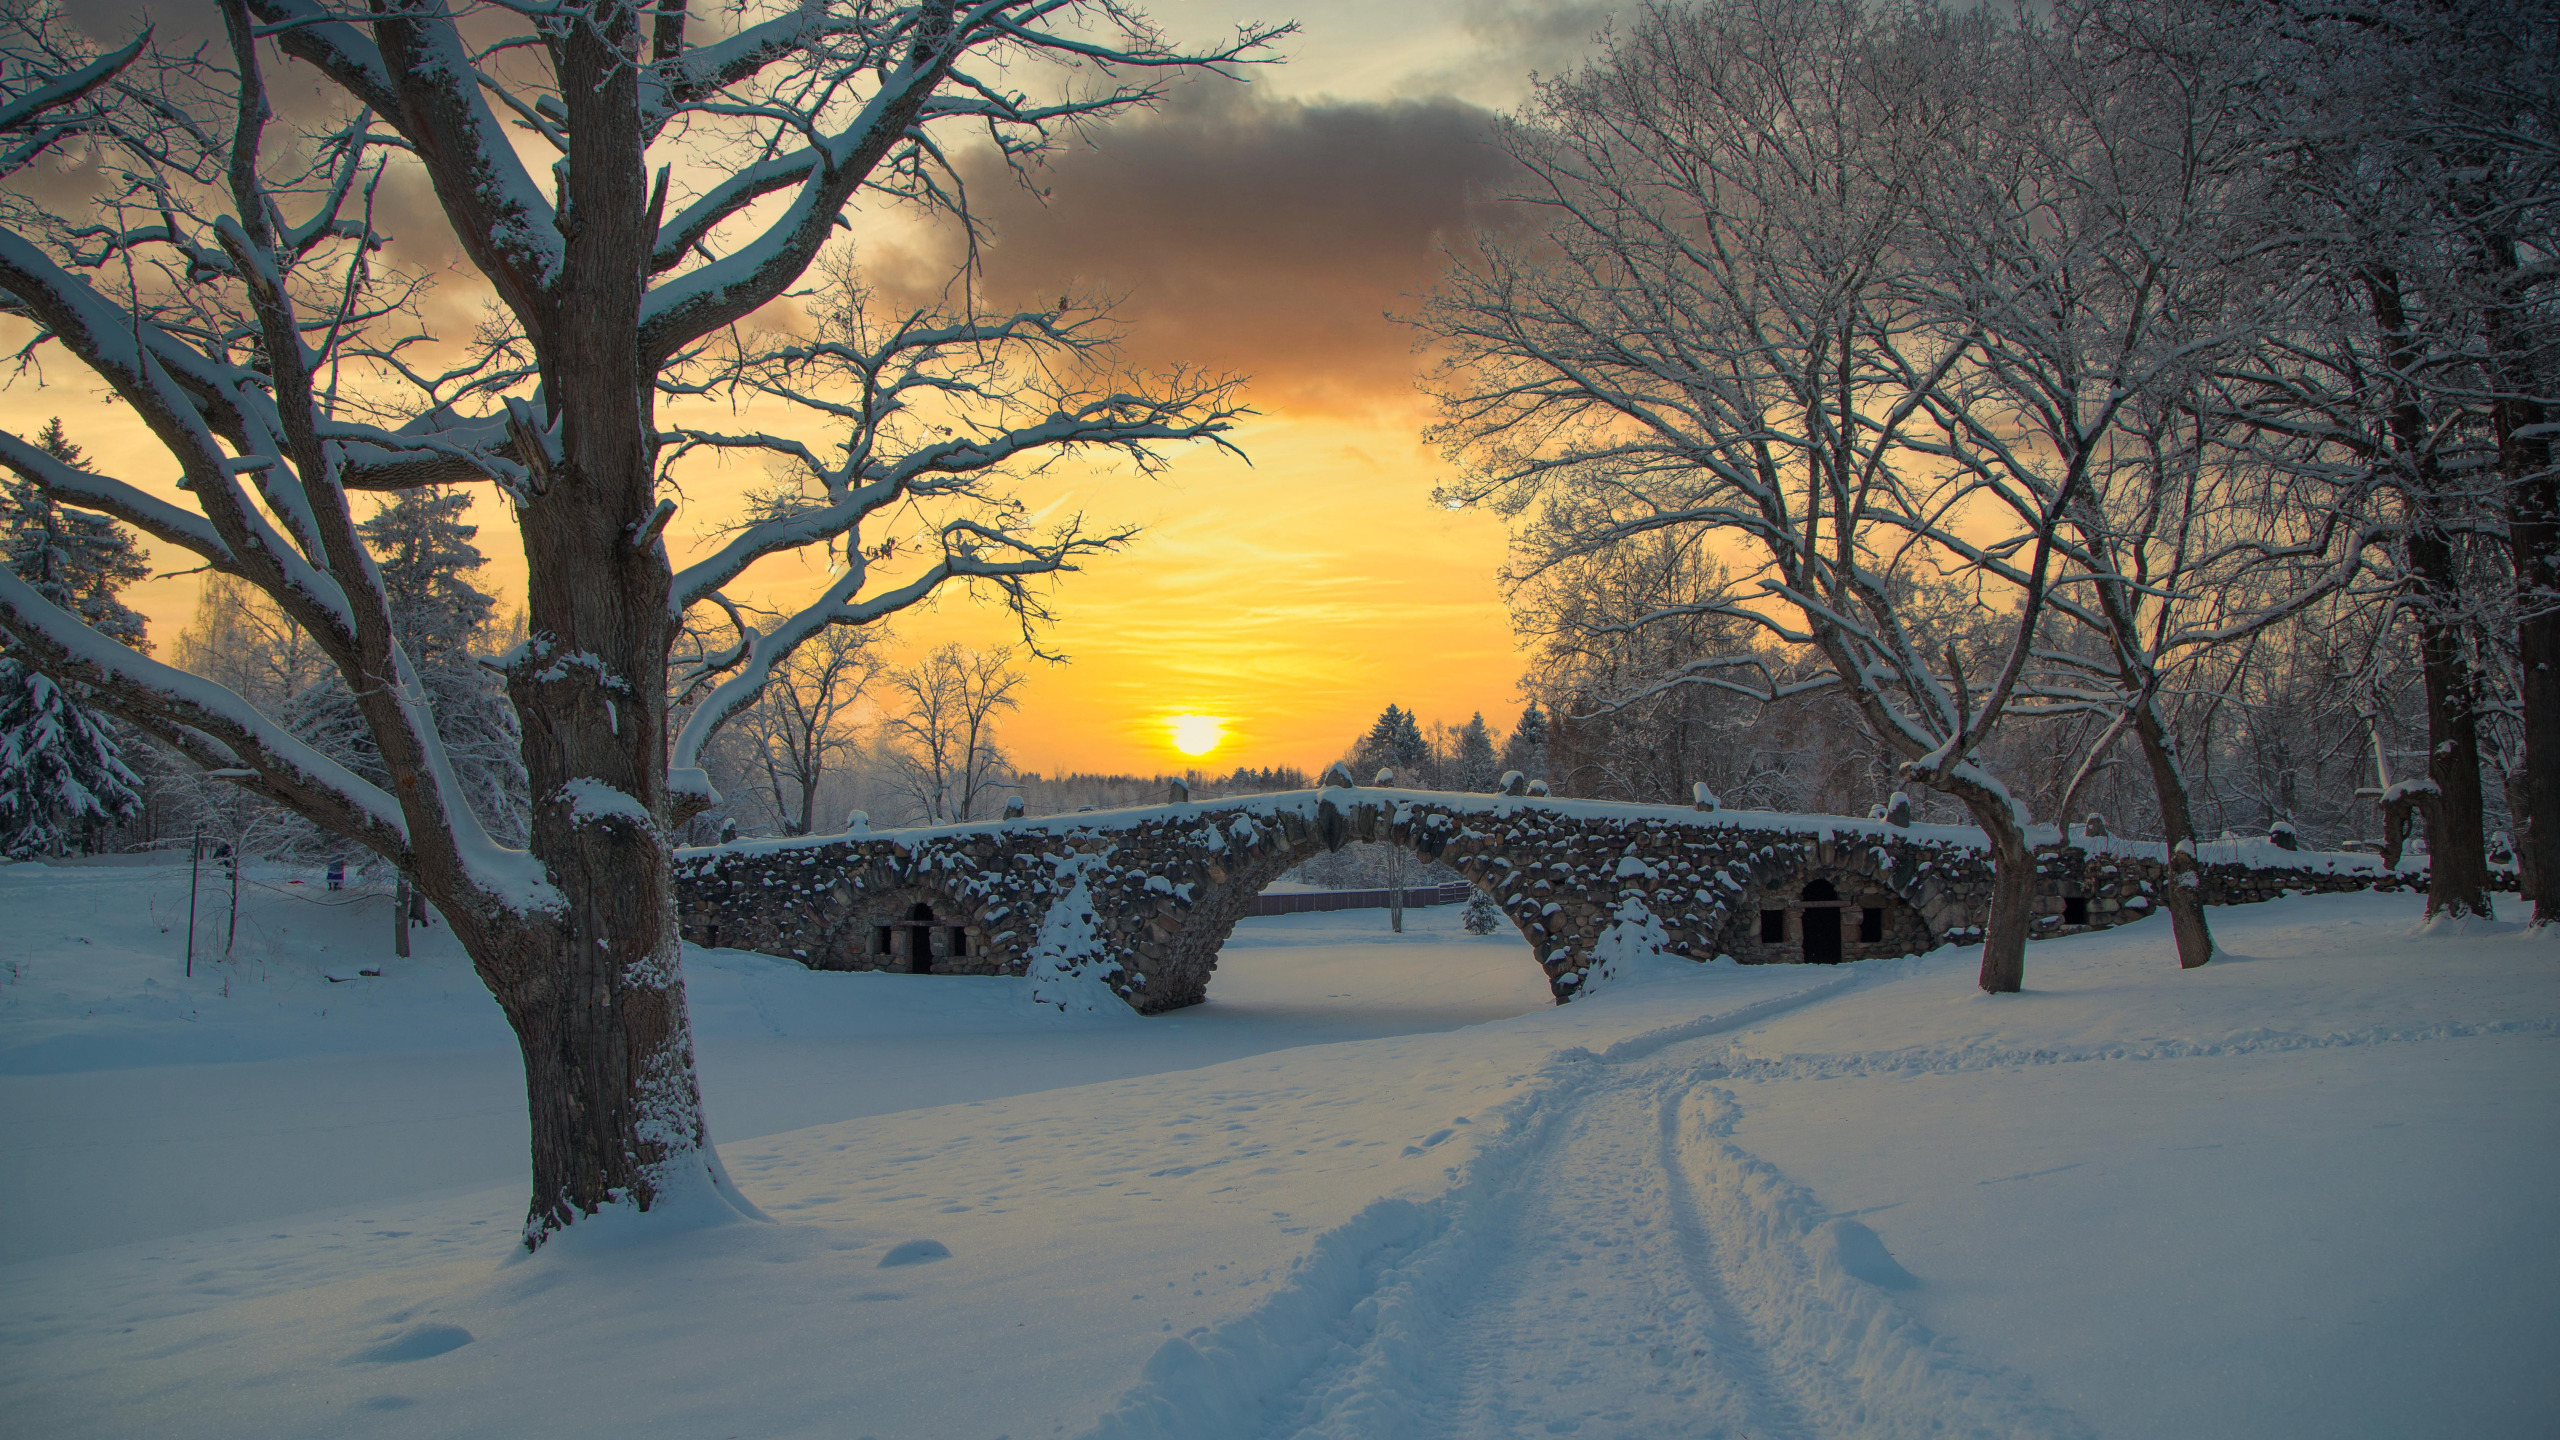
[0,0,1277,1245]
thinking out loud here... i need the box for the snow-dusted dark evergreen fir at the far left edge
[0,418,151,858]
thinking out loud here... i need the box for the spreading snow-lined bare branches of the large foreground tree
[0,0,1275,881]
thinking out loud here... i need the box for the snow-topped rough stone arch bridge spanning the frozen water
[676,789,2409,1015]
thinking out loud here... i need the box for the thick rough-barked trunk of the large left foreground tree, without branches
[481,8,717,1245]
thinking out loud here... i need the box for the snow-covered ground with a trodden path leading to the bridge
[0,850,2560,1440]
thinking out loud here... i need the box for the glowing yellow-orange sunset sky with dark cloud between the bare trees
[5,0,1608,774]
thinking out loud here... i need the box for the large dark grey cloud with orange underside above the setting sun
[931,82,1508,413]
